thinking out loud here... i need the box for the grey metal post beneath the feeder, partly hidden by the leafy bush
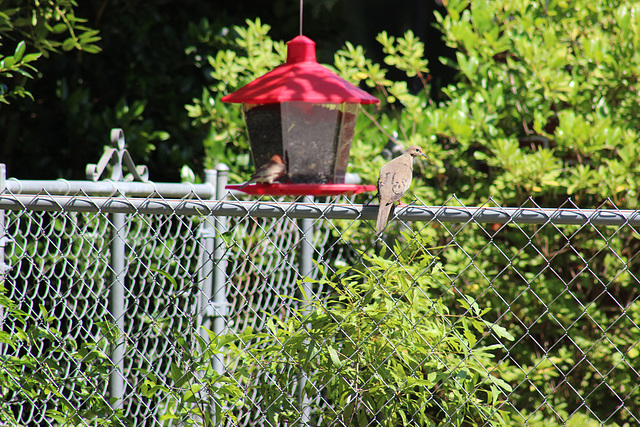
[297,196,315,426]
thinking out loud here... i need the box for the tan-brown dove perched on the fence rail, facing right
[376,145,426,234]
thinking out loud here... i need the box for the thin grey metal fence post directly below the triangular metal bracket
[109,213,126,409]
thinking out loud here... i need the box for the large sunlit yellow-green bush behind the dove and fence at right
[192,0,640,425]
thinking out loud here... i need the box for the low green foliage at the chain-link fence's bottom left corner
[0,284,127,426]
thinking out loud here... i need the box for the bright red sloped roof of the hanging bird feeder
[222,35,380,104]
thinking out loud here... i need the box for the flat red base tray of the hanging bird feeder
[225,184,376,196]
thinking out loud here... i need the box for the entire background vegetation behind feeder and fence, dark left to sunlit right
[0,0,640,425]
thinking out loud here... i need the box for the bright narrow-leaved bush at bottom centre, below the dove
[230,236,513,426]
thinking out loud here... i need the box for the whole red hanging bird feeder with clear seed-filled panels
[222,35,379,195]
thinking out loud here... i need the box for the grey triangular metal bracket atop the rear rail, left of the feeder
[86,129,149,182]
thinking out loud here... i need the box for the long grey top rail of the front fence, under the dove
[0,193,640,227]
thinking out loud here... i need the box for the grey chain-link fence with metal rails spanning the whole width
[0,162,640,426]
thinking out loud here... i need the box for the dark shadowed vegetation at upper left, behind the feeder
[0,0,444,182]
